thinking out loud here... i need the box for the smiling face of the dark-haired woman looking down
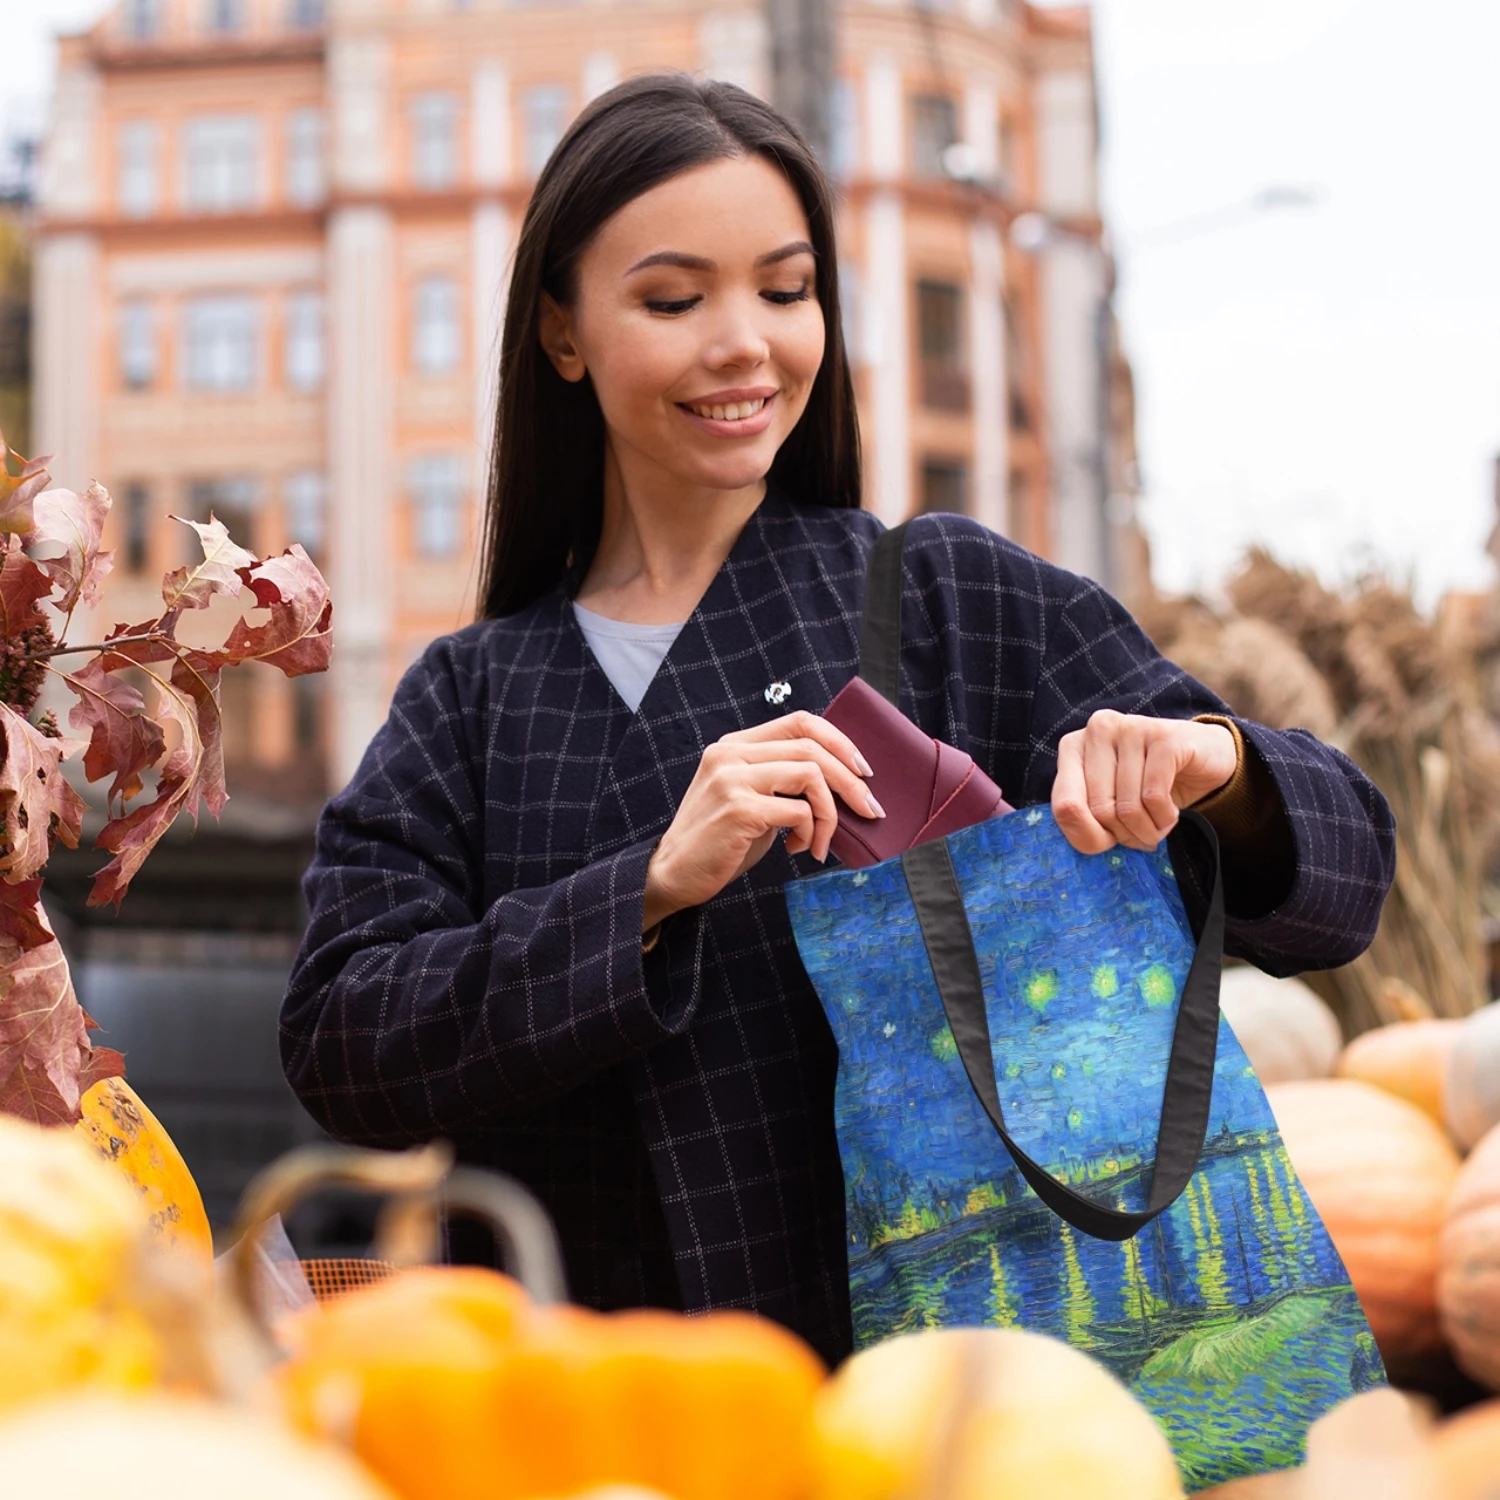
[542,156,825,495]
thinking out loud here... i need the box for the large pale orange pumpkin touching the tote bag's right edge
[1266,1079,1458,1377]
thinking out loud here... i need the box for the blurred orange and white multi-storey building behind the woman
[33,0,1140,806]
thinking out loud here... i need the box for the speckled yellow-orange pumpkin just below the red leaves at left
[74,1079,213,1272]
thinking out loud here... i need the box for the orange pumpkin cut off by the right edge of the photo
[1437,1127,1500,1391]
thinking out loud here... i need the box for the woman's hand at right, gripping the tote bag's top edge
[1052,708,1238,854]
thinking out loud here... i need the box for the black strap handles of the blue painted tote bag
[860,525,1224,1241]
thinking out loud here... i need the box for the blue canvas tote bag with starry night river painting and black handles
[786,530,1385,1491]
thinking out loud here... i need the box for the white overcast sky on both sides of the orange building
[0,0,1500,599]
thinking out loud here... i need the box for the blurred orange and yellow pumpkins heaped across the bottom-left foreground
[0,1085,1182,1500]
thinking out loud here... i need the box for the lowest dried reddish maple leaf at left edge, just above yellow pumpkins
[0,918,125,1125]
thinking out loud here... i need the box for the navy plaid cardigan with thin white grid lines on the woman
[281,492,1394,1361]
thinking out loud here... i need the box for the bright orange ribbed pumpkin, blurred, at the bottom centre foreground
[278,1268,824,1500]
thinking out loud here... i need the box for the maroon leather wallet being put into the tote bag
[824,677,1011,870]
